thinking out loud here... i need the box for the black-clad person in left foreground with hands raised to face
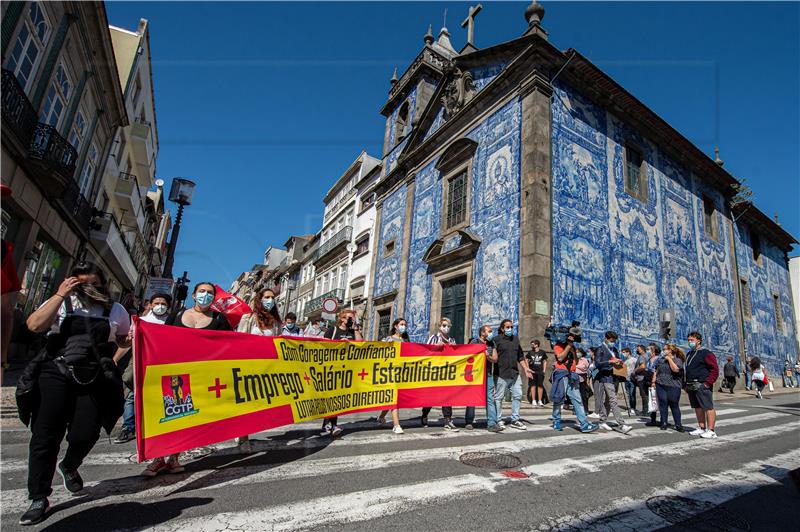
[16,264,131,525]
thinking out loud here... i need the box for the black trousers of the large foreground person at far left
[28,361,101,500]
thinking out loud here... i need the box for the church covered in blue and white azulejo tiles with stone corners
[369,2,798,371]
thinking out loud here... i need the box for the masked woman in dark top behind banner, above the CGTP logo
[142,282,232,477]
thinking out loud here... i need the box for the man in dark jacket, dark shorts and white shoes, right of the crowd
[686,331,719,438]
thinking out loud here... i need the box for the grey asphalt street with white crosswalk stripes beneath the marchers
[0,393,800,532]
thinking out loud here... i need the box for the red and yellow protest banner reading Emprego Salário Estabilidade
[134,321,486,461]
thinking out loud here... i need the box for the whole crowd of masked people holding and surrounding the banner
[9,264,800,525]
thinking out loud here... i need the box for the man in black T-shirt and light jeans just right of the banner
[494,320,533,430]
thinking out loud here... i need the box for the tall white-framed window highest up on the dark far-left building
[7,2,50,93]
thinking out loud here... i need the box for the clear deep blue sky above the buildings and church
[107,0,800,287]
